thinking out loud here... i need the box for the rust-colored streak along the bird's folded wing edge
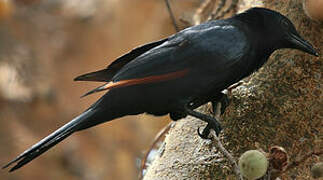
[81,69,189,97]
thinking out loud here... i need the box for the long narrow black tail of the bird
[2,109,96,172]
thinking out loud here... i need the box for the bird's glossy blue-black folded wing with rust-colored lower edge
[84,24,248,96]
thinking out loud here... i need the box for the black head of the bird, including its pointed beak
[238,8,318,56]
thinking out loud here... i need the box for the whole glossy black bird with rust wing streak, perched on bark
[3,8,318,171]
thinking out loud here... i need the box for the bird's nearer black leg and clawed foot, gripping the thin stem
[185,107,222,139]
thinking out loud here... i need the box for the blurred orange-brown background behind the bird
[0,0,201,180]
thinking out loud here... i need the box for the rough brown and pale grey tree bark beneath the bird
[144,0,323,179]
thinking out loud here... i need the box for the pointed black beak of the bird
[289,34,319,56]
